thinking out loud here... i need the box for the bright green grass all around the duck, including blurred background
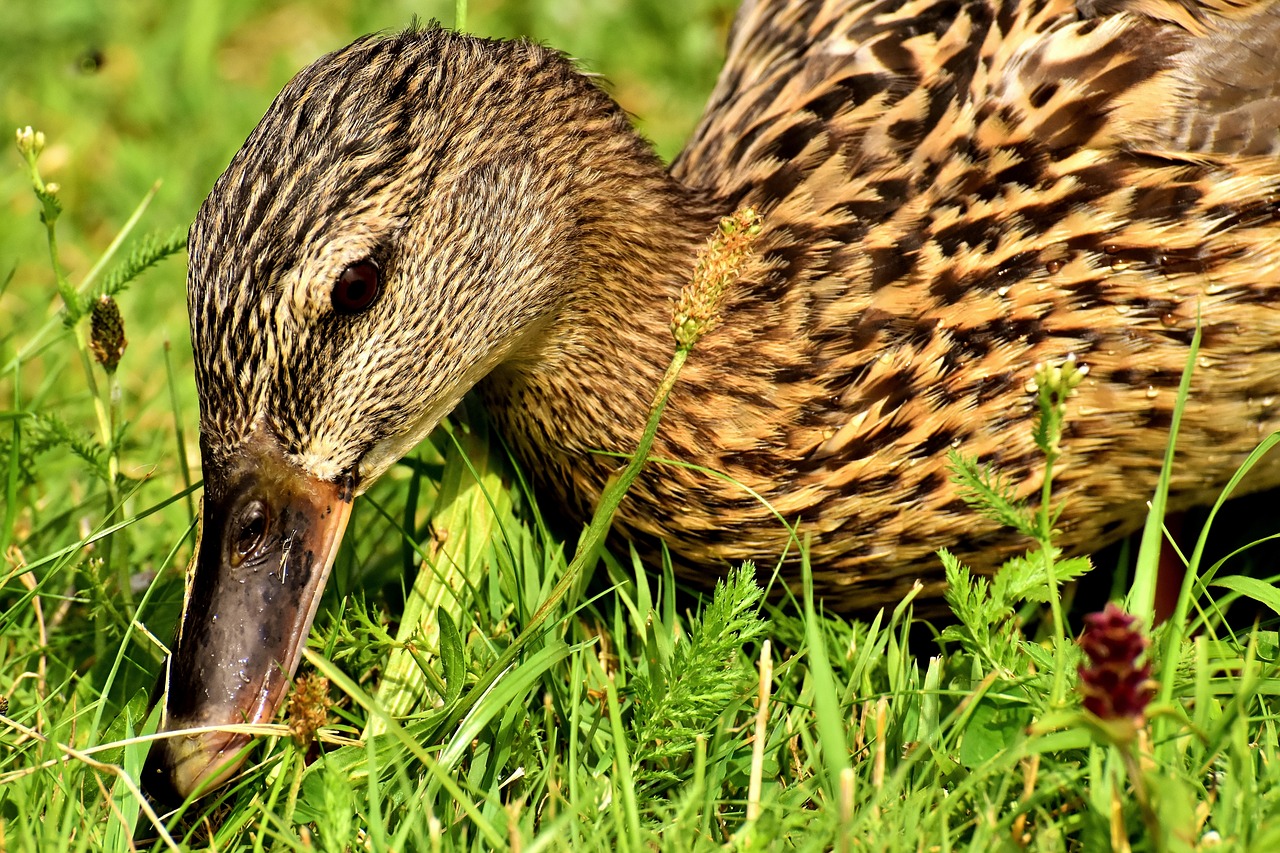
[0,0,1280,850]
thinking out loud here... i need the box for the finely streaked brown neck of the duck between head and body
[481,165,722,494]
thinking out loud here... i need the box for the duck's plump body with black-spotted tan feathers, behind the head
[491,1,1280,611]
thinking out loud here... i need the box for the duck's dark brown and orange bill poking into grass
[143,429,352,804]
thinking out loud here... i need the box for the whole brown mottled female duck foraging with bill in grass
[147,0,1280,795]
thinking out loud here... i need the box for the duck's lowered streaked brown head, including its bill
[145,28,666,802]
